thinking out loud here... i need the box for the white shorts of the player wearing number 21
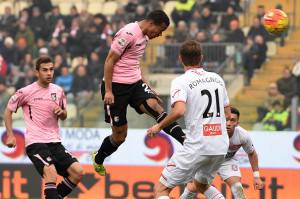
[159,151,224,188]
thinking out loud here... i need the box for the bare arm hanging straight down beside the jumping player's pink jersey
[104,50,120,105]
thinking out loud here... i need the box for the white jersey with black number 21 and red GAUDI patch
[170,68,229,155]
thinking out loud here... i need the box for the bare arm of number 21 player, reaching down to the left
[148,101,186,136]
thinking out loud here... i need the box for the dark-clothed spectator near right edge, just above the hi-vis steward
[276,67,298,108]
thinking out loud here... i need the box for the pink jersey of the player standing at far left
[7,82,66,146]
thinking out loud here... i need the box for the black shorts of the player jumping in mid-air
[101,80,157,126]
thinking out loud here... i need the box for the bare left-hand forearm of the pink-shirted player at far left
[4,108,16,148]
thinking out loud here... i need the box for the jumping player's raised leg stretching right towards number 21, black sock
[130,81,185,144]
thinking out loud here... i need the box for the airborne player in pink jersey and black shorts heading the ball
[93,10,184,175]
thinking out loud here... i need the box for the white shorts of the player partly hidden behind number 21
[218,159,241,180]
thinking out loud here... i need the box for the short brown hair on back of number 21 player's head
[180,40,202,66]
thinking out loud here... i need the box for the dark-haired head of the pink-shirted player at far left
[35,57,54,86]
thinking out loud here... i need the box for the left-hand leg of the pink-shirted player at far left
[26,143,59,199]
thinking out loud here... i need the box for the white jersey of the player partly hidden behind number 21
[225,126,255,161]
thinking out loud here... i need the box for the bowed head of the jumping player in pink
[145,10,170,39]
